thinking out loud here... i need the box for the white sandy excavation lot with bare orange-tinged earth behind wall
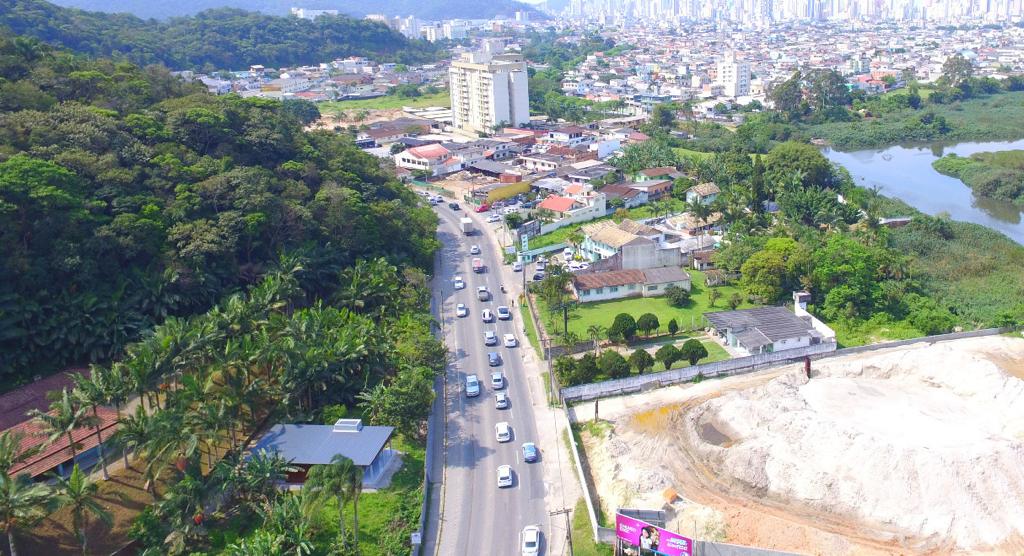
[574,336,1024,554]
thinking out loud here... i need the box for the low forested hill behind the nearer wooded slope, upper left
[0,0,440,72]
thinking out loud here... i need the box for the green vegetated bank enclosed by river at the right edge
[932,151,1024,210]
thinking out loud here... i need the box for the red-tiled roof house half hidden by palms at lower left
[0,370,118,480]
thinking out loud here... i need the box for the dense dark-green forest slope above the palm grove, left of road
[0,30,435,387]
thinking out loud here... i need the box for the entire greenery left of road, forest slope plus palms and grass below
[0,35,446,554]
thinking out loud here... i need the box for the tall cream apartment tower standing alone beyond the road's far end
[450,52,529,133]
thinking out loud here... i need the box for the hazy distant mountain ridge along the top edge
[44,0,540,20]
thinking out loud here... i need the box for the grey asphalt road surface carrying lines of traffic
[434,204,549,556]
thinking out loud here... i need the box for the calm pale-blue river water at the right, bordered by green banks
[823,139,1024,245]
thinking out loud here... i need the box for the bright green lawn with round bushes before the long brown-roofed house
[538,269,754,339]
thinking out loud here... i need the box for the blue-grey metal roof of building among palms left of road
[253,419,394,467]
